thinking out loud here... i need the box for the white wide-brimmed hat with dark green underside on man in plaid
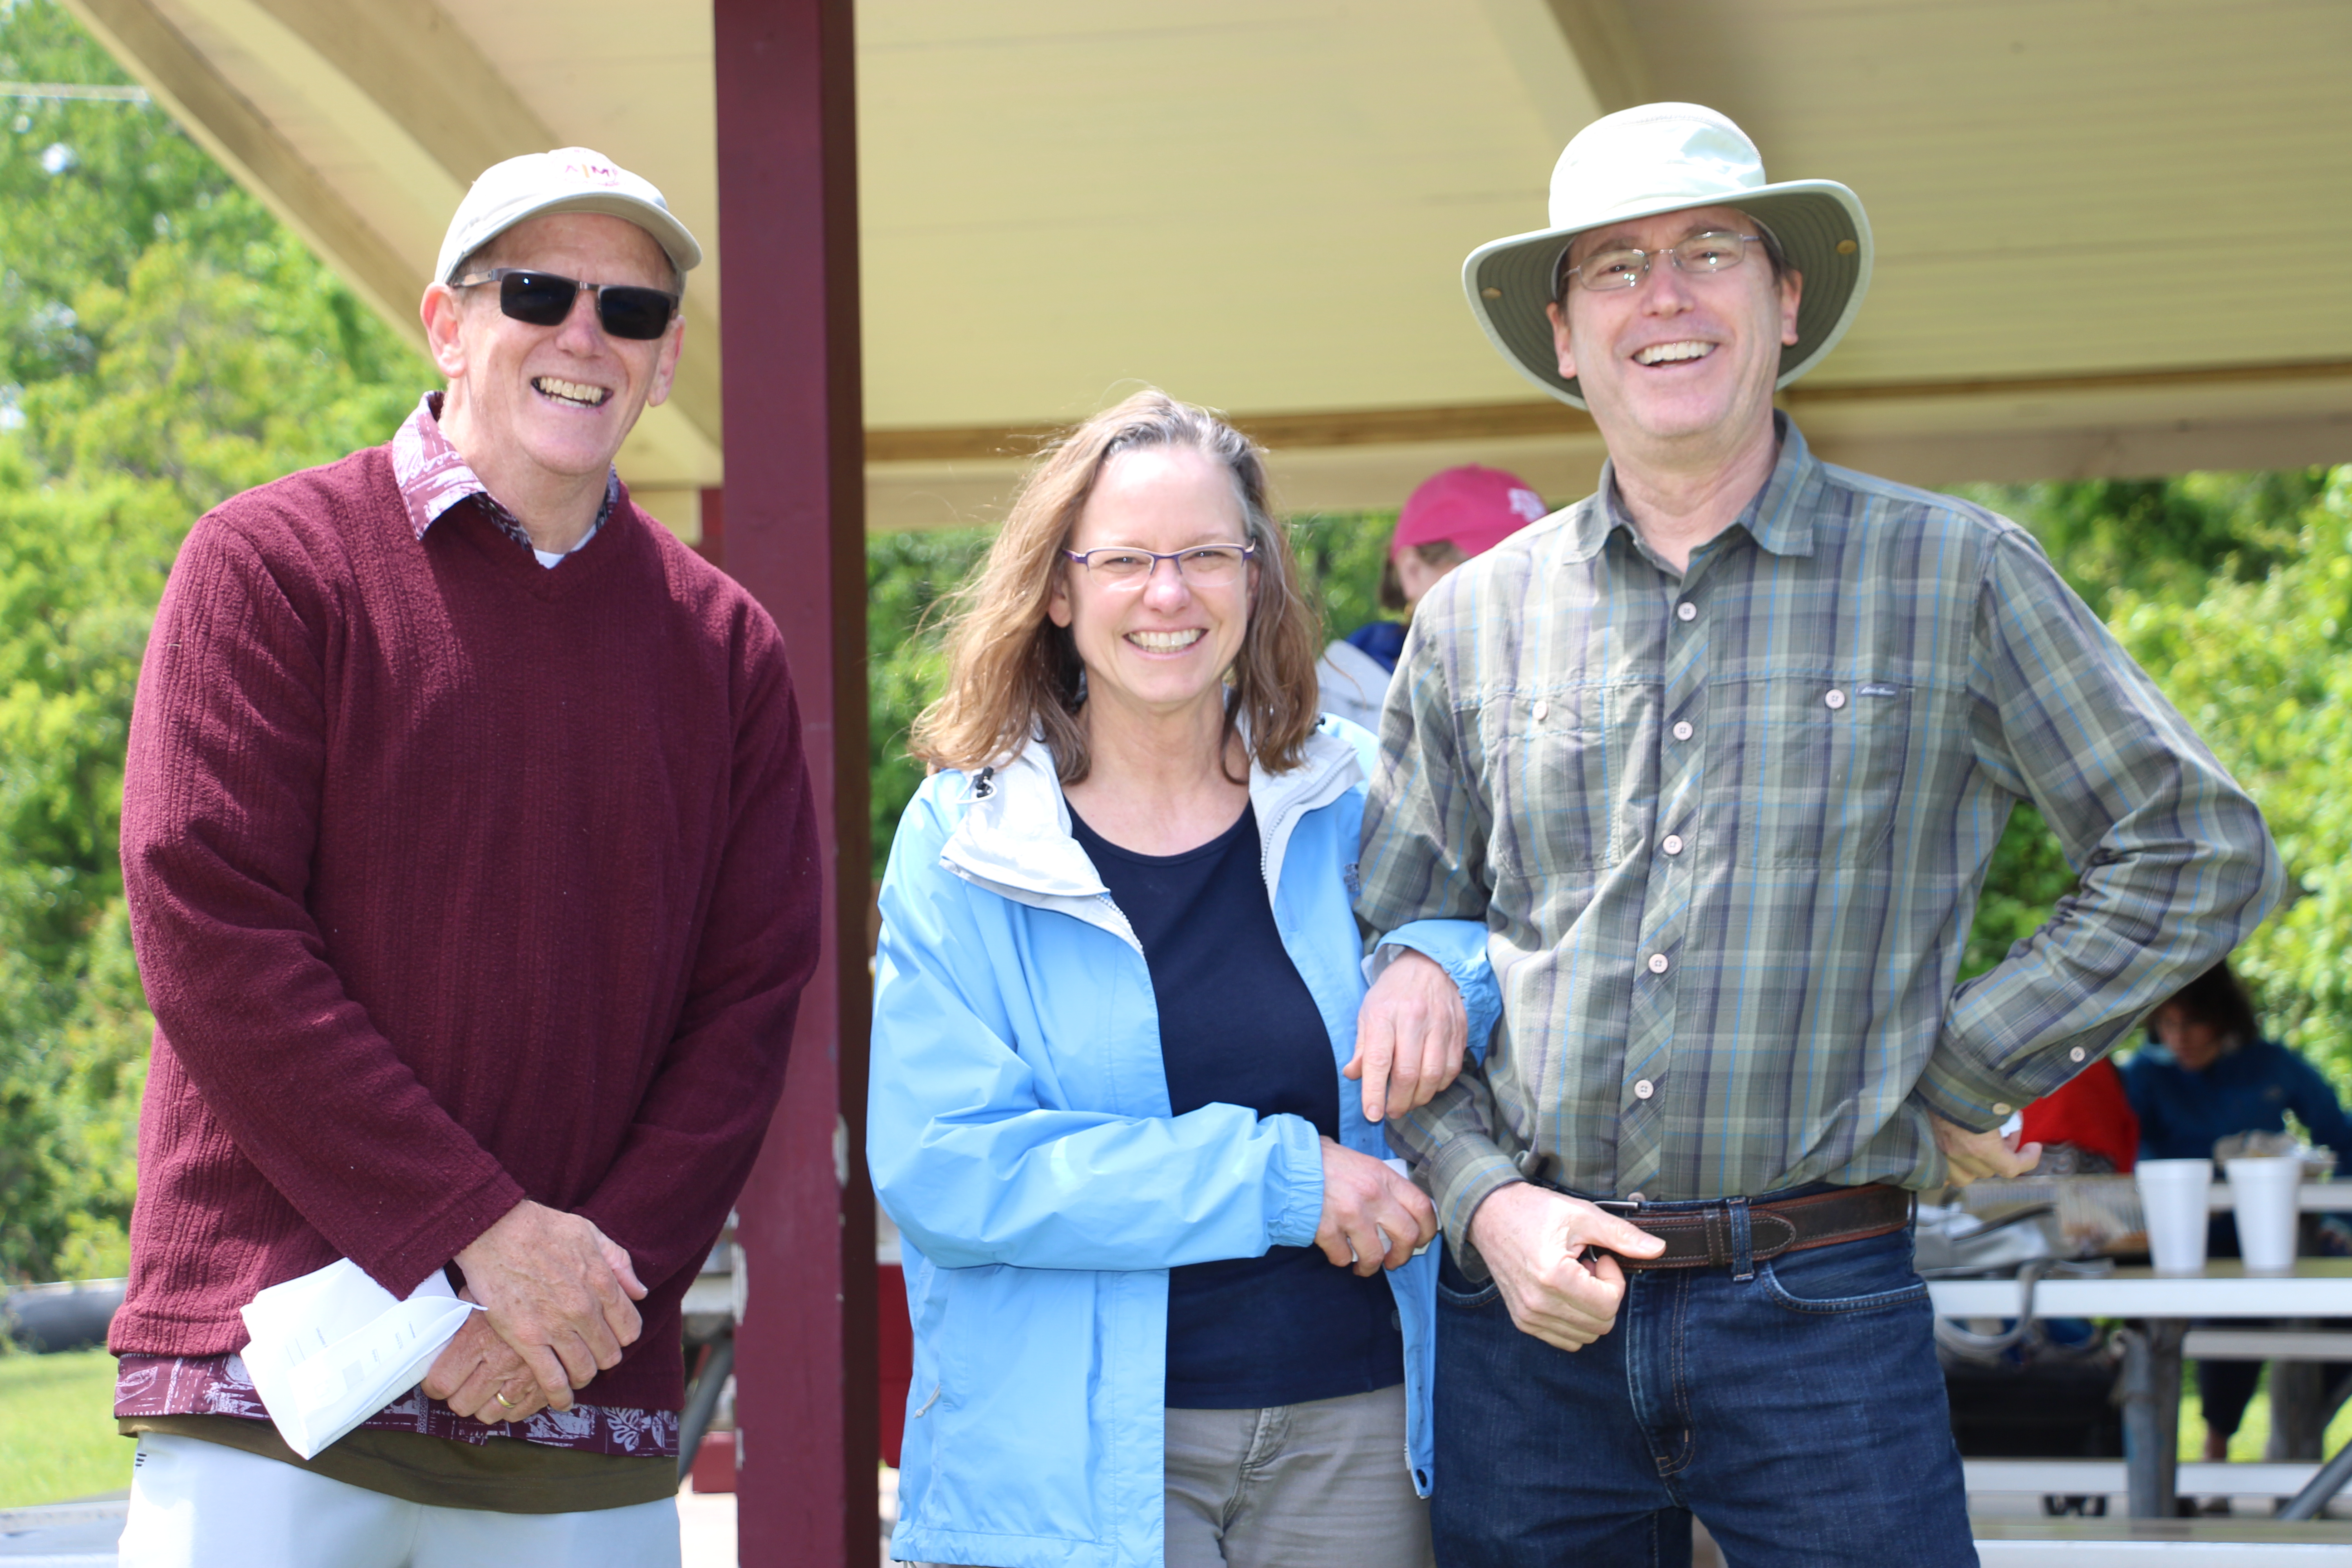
[1463,103,1870,409]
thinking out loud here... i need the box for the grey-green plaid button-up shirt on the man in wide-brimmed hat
[1357,423,2281,1246]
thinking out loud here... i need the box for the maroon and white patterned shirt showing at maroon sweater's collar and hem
[115,392,677,1457]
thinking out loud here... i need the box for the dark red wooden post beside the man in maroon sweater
[710,0,877,1568]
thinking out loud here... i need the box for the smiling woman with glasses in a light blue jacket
[868,392,1498,1568]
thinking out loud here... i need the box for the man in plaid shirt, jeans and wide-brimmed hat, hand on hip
[1357,103,2281,1566]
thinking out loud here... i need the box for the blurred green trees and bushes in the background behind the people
[0,0,2352,1281]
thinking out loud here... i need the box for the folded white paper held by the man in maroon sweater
[242,1258,480,1460]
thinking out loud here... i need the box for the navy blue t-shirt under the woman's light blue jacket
[1070,808,1404,1411]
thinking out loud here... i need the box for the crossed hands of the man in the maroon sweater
[423,1201,644,1422]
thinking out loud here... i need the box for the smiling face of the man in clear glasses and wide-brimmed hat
[1548,207,1802,461]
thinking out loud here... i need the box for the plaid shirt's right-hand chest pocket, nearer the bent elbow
[1708,675,1915,867]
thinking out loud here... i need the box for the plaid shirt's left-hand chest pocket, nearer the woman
[1484,686,1658,879]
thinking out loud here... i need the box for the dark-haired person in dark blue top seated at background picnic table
[2124,959,2352,1460]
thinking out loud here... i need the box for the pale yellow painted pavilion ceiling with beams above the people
[68,0,2352,524]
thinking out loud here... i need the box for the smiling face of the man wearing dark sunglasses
[426,211,685,482]
